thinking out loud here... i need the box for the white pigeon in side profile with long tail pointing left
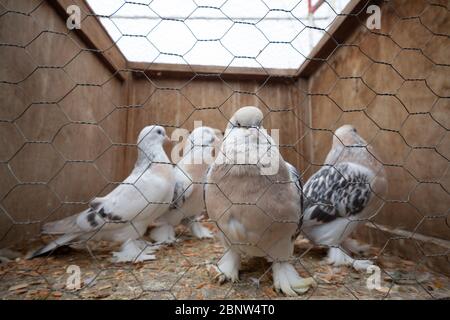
[29,126,175,261]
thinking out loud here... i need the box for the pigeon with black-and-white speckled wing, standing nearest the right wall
[302,125,387,270]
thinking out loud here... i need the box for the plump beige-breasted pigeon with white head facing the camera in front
[205,107,313,296]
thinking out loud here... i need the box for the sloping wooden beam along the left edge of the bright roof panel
[48,0,127,81]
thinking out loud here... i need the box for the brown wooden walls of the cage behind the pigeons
[0,0,450,274]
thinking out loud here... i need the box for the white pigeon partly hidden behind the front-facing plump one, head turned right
[150,127,220,243]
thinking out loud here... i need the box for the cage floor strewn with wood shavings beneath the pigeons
[0,225,450,299]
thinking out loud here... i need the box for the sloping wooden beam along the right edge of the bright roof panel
[295,0,382,78]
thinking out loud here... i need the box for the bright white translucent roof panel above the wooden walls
[87,0,350,69]
